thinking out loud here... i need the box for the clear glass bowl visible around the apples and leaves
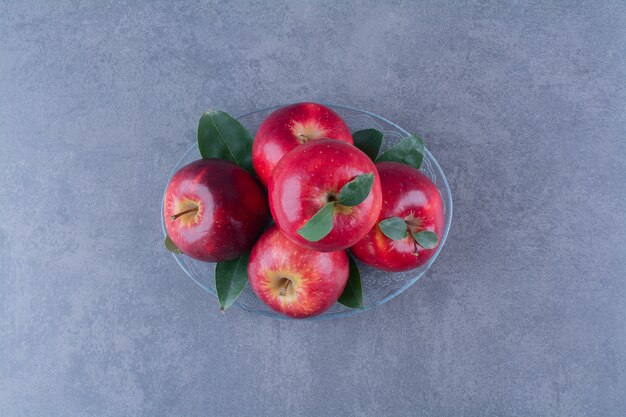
[161,104,452,320]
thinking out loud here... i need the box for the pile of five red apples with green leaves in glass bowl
[163,102,444,318]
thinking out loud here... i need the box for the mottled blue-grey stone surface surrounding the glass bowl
[0,1,626,417]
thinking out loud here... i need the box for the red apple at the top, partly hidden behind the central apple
[252,103,353,186]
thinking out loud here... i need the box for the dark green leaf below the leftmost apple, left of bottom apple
[215,253,250,311]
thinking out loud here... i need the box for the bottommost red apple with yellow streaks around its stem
[248,226,349,318]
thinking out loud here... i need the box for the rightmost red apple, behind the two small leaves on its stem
[350,162,444,271]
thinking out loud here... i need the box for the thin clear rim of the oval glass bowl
[161,102,453,321]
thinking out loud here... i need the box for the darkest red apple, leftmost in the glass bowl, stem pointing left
[163,159,269,262]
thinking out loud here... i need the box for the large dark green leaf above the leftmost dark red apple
[198,109,254,173]
